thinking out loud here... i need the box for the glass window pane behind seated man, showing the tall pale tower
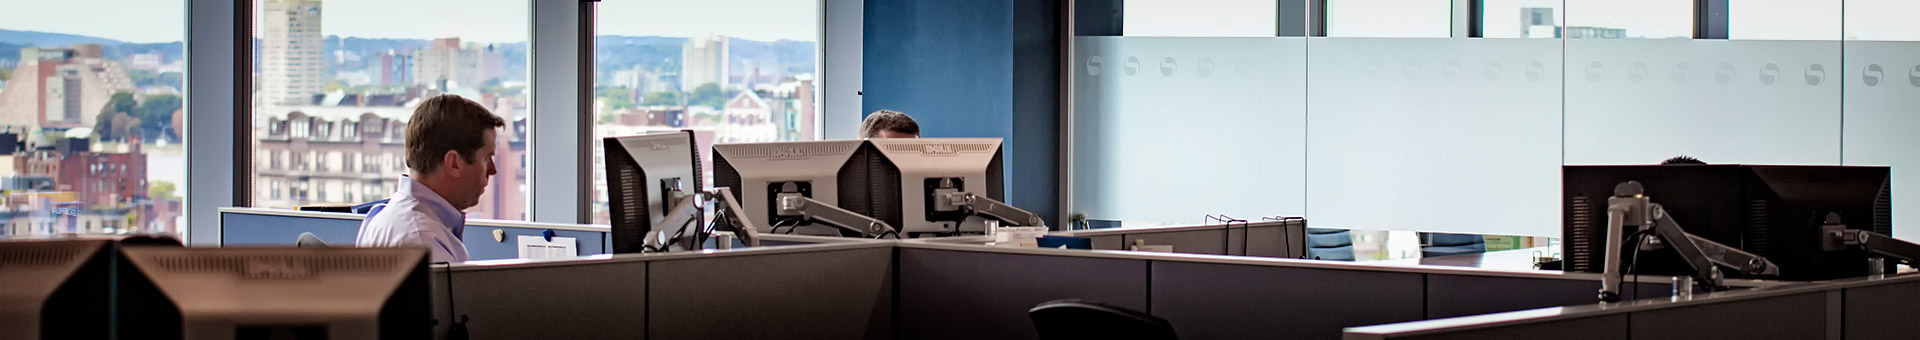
[253,0,532,219]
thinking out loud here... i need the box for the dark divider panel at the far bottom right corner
[1843,280,1920,340]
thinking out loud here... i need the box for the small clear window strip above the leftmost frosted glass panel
[1121,0,1279,36]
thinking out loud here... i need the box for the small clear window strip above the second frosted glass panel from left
[1328,0,1453,38]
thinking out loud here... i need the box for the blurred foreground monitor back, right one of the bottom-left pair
[119,248,434,340]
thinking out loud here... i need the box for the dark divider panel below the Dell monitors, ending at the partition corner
[645,246,895,340]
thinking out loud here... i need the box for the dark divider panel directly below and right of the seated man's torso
[432,261,647,340]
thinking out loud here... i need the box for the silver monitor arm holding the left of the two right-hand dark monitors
[1599,181,1780,302]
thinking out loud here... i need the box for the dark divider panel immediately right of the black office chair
[1148,261,1427,340]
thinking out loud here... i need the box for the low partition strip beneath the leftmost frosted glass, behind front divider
[1052,219,1308,257]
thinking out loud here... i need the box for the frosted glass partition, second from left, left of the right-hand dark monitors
[1306,38,1561,234]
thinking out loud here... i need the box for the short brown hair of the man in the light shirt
[407,94,507,175]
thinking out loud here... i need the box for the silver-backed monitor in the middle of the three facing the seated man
[714,140,879,236]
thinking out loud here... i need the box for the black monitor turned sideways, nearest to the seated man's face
[603,131,707,254]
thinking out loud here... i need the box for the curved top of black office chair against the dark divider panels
[1027,300,1179,340]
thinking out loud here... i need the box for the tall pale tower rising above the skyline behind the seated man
[259,0,326,106]
